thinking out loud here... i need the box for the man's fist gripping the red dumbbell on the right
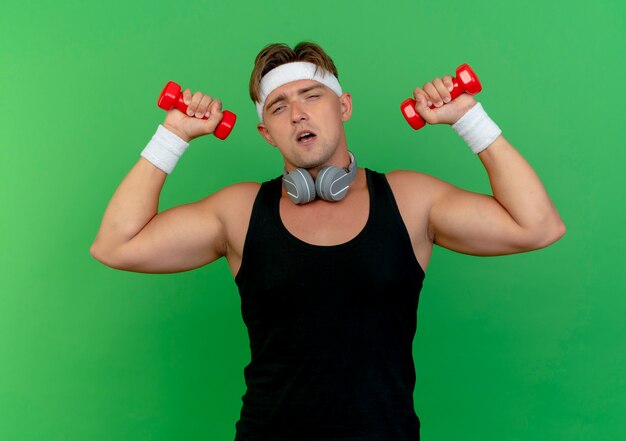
[413,75,476,124]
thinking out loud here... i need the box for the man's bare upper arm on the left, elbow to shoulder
[116,196,226,273]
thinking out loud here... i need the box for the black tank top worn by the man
[235,169,424,441]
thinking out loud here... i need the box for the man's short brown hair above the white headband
[250,41,339,103]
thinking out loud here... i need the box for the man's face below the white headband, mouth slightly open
[258,80,352,171]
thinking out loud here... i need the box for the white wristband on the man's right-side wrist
[452,103,502,153]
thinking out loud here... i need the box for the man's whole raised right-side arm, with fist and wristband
[414,75,565,255]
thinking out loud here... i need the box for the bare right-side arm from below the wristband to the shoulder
[429,135,565,255]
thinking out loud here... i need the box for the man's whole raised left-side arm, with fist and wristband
[91,85,237,273]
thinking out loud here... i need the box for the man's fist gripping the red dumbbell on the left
[163,89,224,142]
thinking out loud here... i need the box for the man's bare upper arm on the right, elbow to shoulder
[429,181,527,256]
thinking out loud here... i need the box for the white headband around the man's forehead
[256,61,341,122]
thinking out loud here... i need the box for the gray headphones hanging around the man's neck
[283,152,357,204]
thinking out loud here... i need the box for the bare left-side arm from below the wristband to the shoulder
[91,158,226,273]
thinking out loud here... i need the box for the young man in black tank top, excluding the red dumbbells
[91,43,565,441]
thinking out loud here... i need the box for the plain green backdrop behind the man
[0,0,626,441]
